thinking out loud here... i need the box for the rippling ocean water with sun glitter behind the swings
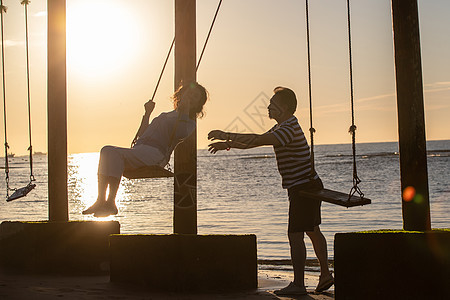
[0,140,450,261]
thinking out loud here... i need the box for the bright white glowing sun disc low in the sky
[66,0,140,78]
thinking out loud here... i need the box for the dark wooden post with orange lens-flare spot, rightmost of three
[392,0,431,231]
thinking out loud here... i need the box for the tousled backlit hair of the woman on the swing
[172,82,208,118]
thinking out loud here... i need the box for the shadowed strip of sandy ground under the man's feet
[0,270,334,300]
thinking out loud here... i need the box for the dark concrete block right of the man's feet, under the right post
[334,229,450,300]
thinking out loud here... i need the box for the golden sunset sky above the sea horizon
[1,0,450,154]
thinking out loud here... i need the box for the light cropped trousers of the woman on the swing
[98,145,168,178]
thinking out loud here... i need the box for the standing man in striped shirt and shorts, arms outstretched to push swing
[208,87,334,295]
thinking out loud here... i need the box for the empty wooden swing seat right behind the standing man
[299,189,372,207]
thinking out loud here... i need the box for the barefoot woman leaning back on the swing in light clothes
[83,82,208,217]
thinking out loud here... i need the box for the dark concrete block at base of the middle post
[110,234,258,291]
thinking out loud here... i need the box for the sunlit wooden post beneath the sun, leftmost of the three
[47,0,69,221]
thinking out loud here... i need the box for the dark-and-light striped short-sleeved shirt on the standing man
[268,116,319,189]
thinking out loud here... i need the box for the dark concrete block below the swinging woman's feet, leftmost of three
[0,221,120,274]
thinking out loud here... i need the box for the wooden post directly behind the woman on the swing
[173,0,197,234]
